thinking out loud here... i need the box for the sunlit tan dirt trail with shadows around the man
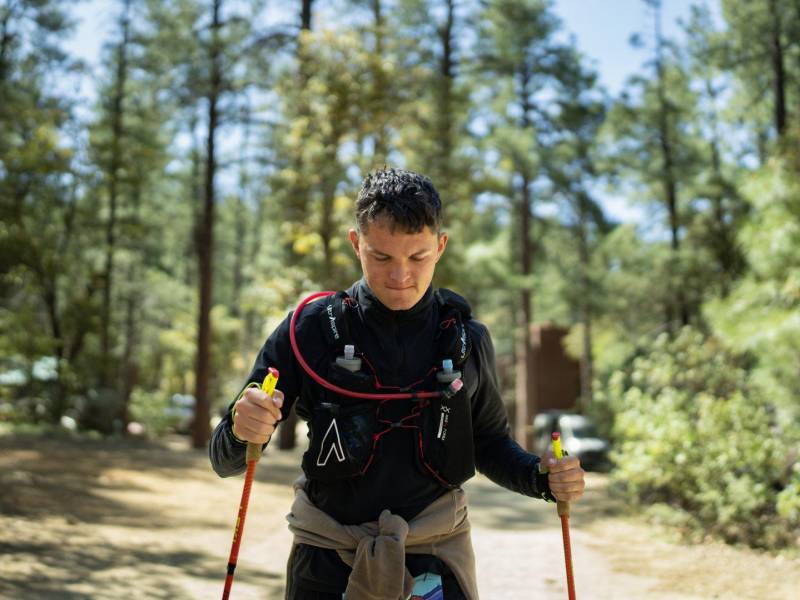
[0,436,800,600]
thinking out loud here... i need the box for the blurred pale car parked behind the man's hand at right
[533,410,611,471]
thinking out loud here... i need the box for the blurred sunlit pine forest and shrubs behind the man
[0,0,800,548]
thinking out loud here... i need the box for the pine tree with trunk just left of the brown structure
[477,0,566,447]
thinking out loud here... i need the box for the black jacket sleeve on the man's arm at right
[470,321,555,501]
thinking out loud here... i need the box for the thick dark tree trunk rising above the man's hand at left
[192,0,222,448]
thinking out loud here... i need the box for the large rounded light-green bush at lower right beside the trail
[601,328,800,548]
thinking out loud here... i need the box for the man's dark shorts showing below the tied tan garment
[286,544,466,600]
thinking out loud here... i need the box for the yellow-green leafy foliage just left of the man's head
[271,31,374,285]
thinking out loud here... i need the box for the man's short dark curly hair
[356,168,442,234]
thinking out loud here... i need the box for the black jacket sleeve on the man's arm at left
[208,313,305,477]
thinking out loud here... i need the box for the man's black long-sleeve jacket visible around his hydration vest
[209,279,552,592]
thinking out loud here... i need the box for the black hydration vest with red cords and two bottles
[300,289,476,488]
